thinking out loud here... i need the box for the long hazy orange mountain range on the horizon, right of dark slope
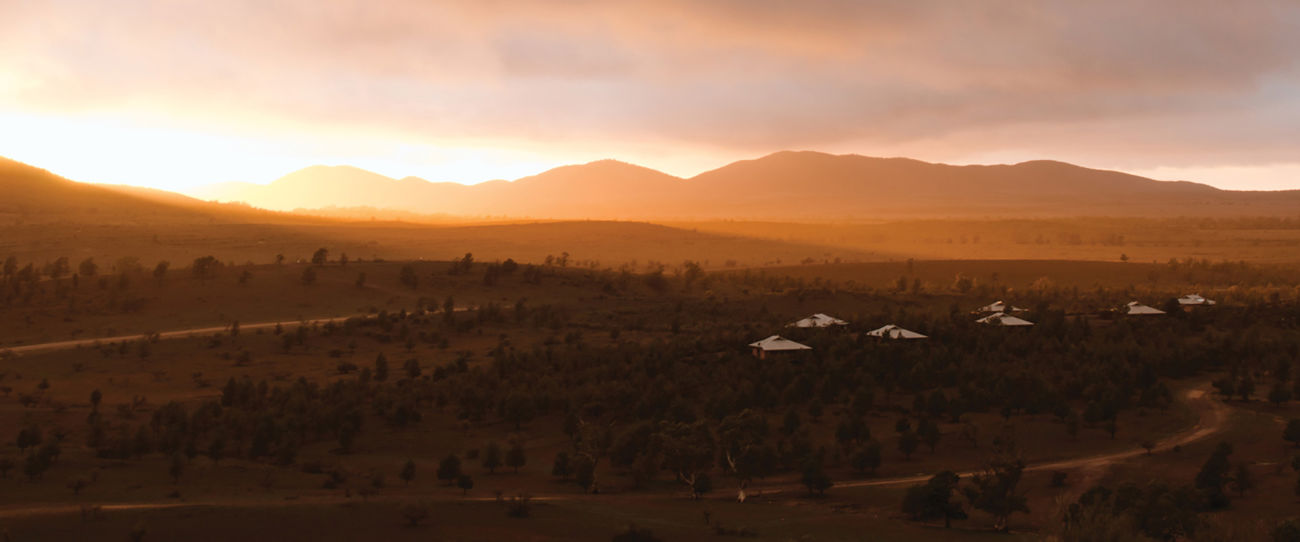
[175,151,1300,220]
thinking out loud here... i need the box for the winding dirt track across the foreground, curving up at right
[0,382,1231,519]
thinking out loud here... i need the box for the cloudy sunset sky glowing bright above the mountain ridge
[0,0,1300,190]
